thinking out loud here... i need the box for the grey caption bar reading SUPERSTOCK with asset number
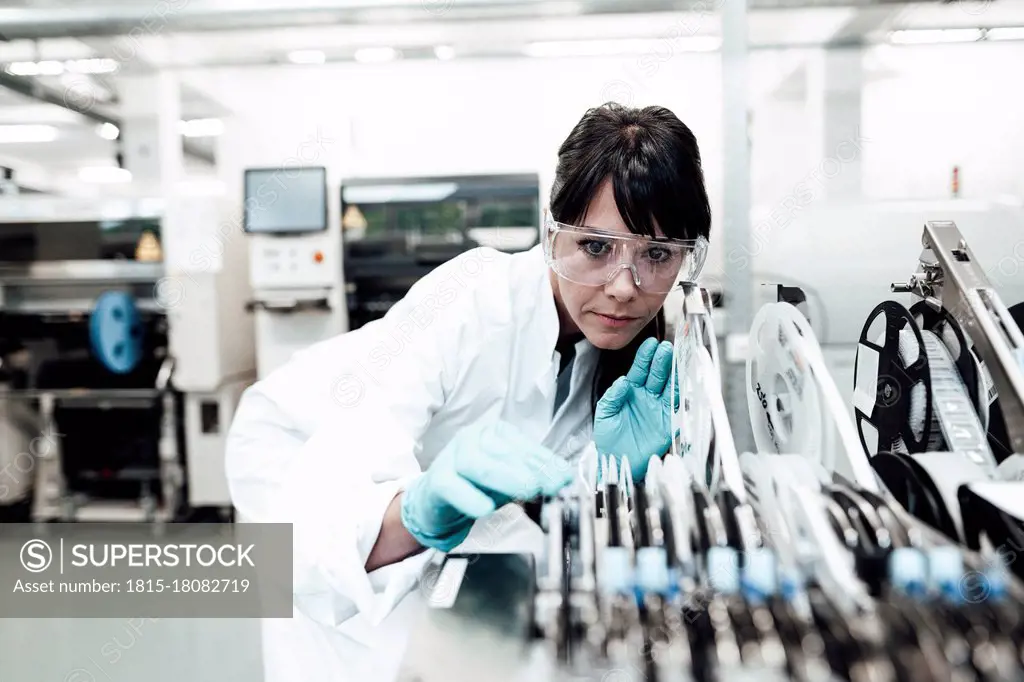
[0,523,292,619]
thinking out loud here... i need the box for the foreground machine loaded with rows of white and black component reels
[399,223,1024,682]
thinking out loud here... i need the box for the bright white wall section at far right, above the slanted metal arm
[864,43,1024,199]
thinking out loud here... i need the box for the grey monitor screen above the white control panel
[244,167,327,233]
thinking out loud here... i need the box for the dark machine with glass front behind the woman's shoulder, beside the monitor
[341,174,541,329]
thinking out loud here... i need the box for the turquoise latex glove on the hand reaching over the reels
[401,422,572,552]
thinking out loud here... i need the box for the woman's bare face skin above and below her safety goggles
[550,180,668,350]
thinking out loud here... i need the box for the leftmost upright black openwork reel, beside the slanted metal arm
[854,301,933,457]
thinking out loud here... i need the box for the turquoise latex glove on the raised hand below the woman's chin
[594,338,672,480]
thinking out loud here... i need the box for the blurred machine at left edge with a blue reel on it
[0,196,253,521]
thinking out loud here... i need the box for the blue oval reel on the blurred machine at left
[89,291,142,374]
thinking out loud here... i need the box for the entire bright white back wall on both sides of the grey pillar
[183,43,1024,280]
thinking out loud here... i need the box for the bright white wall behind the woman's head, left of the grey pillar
[186,55,722,260]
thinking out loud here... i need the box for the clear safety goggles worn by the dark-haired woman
[544,211,708,294]
